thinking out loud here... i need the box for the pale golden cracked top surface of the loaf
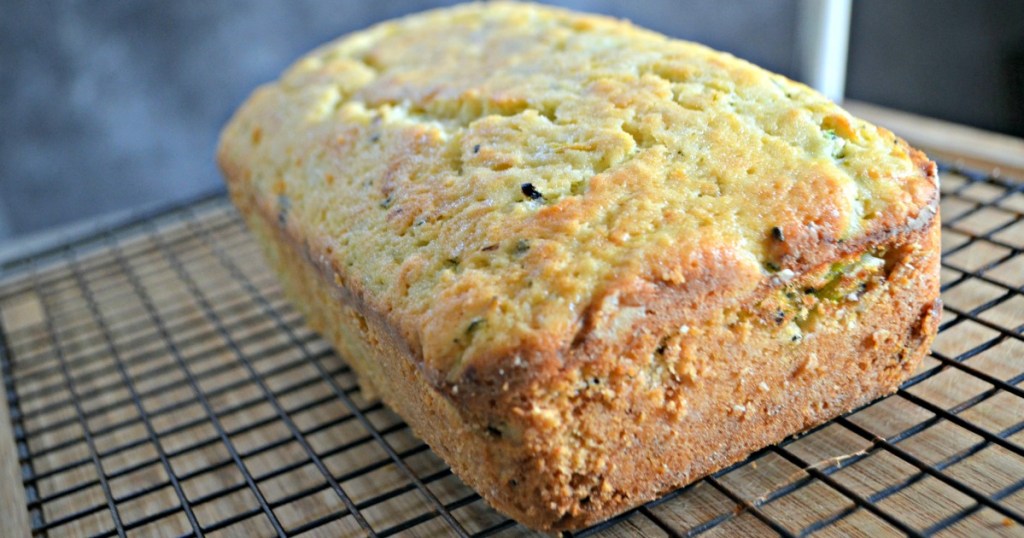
[219,3,937,383]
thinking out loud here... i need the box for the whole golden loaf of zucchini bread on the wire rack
[218,3,940,530]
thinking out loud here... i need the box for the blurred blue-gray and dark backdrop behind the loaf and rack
[0,0,1024,246]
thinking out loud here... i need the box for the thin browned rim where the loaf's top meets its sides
[217,137,939,393]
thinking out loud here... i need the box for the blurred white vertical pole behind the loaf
[798,0,852,101]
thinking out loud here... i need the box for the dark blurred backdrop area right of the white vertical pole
[846,0,1024,137]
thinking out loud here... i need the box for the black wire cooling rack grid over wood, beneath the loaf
[0,163,1024,536]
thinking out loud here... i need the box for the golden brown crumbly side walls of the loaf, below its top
[240,188,939,530]
